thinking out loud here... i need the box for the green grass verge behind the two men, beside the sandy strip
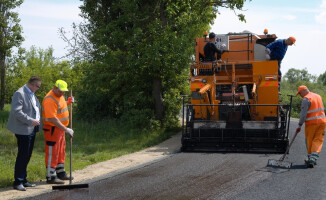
[0,105,180,188]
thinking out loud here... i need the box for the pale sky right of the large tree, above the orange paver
[211,0,326,75]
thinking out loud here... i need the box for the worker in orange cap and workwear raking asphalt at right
[296,85,326,168]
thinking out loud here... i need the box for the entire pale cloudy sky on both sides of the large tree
[17,0,326,75]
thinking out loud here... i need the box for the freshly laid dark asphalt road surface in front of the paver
[29,122,326,200]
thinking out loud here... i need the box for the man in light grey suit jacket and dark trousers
[7,76,42,191]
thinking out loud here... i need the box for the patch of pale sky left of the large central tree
[17,0,83,58]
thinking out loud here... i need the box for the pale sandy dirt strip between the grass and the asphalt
[0,133,181,199]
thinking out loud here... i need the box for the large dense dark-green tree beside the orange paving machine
[74,0,245,123]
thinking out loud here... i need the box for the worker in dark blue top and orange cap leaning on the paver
[265,36,296,90]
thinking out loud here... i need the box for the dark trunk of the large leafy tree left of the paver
[153,78,164,121]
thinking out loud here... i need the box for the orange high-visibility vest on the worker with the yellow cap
[42,90,69,126]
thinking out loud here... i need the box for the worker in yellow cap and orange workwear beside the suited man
[42,80,74,184]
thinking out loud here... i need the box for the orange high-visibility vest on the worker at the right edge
[304,92,326,125]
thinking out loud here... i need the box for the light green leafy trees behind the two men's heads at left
[6,46,83,103]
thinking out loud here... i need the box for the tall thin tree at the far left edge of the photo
[0,0,24,110]
